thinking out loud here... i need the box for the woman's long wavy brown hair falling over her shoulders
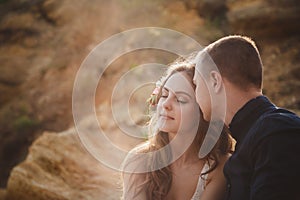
[131,54,232,200]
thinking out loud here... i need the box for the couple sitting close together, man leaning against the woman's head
[122,36,300,200]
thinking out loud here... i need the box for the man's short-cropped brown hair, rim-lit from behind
[205,35,263,90]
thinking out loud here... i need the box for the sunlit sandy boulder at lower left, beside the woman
[3,130,121,200]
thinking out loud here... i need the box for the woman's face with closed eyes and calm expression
[157,72,200,134]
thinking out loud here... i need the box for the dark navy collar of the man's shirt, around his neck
[229,96,275,142]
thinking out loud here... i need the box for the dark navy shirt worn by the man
[224,96,300,200]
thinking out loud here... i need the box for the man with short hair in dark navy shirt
[193,36,300,200]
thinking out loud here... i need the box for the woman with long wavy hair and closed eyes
[123,55,231,200]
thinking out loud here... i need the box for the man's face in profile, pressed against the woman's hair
[193,66,212,121]
